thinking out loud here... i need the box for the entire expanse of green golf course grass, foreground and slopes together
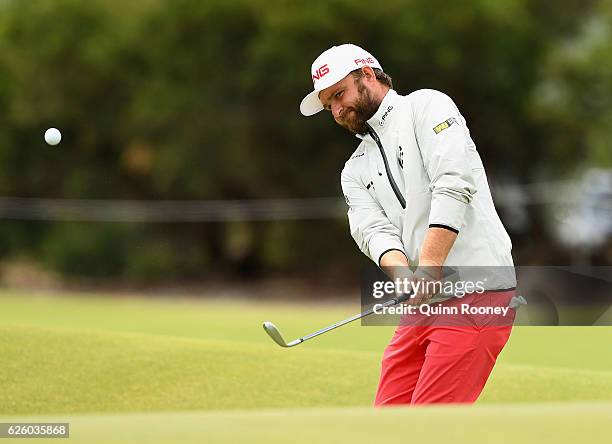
[0,292,612,443]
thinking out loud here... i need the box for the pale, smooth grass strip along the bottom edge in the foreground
[0,402,612,444]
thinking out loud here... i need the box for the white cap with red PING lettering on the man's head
[300,43,382,116]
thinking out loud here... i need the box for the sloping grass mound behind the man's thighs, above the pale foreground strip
[0,325,612,414]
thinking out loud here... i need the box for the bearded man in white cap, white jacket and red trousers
[300,44,516,406]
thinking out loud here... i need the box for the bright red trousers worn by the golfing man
[374,290,515,406]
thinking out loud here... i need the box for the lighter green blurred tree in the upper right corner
[531,1,612,175]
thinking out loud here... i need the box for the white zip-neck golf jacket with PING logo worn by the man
[341,89,516,289]
